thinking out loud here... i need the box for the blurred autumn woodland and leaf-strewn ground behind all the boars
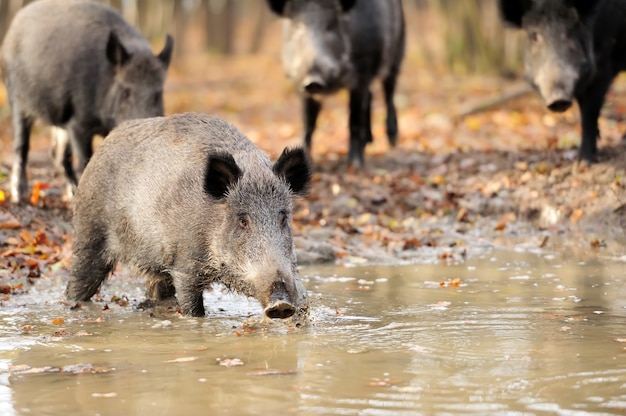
[0,0,626,293]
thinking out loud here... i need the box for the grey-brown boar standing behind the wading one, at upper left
[0,0,173,202]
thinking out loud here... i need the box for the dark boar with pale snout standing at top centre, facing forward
[268,0,405,167]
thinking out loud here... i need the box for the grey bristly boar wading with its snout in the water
[66,113,311,318]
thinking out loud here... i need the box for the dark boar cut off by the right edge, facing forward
[499,0,626,163]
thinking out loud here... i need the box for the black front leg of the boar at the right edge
[576,75,613,163]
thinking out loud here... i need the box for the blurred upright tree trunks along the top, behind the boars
[0,0,521,74]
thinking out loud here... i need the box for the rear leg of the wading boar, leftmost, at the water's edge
[65,241,113,301]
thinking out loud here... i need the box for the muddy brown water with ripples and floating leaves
[0,251,626,416]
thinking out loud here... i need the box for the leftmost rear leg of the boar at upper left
[11,103,33,203]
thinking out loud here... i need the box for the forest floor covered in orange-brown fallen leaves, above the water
[0,51,626,295]
